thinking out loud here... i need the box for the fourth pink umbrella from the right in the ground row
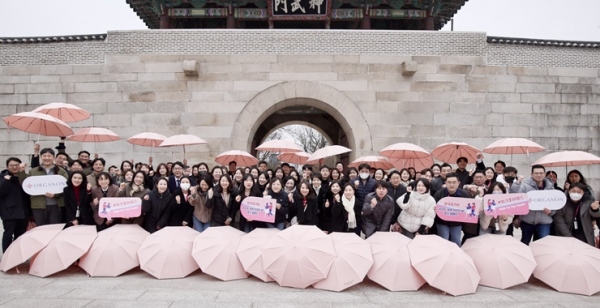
[366,232,425,291]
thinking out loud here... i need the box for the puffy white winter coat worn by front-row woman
[396,192,436,233]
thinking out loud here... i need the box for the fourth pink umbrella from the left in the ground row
[138,226,198,279]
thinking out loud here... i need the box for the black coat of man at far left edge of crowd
[0,170,31,220]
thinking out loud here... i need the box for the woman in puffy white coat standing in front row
[396,178,435,239]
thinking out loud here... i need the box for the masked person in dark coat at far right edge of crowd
[552,182,600,246]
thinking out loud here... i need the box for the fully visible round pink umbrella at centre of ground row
[262,225,336,289]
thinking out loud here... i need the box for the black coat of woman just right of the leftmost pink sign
[142,187,175,233]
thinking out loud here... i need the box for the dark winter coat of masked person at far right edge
[552,194,600,246]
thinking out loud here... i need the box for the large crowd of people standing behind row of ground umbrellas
[0,144,600,251]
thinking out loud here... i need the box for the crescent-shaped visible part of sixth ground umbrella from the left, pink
[235,228,279,282]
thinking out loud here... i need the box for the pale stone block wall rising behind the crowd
[0,30,600,190]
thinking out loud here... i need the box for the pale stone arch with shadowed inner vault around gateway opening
[230,81,373,159]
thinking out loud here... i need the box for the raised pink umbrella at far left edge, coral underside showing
[2,112,73,137]
